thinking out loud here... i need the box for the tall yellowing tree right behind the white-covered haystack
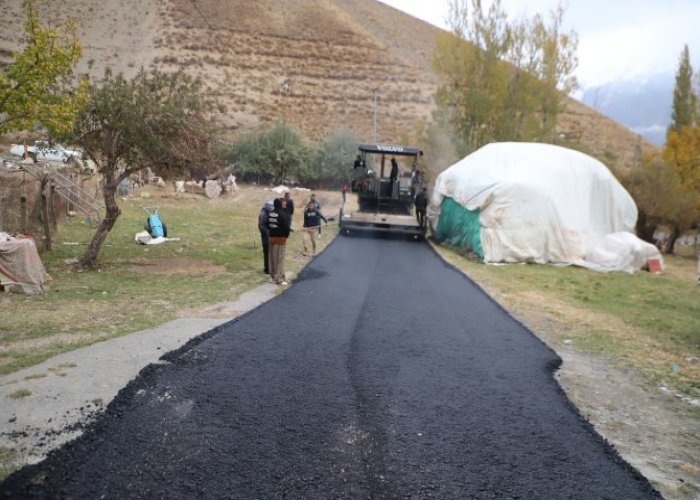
[433,0,578,154]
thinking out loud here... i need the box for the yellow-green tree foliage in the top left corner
[0,0,87,134]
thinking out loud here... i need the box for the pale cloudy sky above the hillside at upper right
[380,0,700,88]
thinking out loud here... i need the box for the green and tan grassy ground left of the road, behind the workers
[0,186,341,374]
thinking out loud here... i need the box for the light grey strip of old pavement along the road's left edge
[0,283,279,470]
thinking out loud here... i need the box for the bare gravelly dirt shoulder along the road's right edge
[489,290,700,500]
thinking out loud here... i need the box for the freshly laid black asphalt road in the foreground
[0,237,658,499]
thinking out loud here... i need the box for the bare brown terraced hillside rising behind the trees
[0,0,653,172]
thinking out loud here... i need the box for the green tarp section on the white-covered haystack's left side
[433,197,484,260]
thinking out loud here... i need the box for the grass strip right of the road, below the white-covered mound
[436,246,700,398]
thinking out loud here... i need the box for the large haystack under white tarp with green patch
[429,143,661,272]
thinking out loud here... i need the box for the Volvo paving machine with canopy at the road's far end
[339,144,425,239]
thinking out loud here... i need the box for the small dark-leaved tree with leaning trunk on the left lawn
[65,70,221,267]
